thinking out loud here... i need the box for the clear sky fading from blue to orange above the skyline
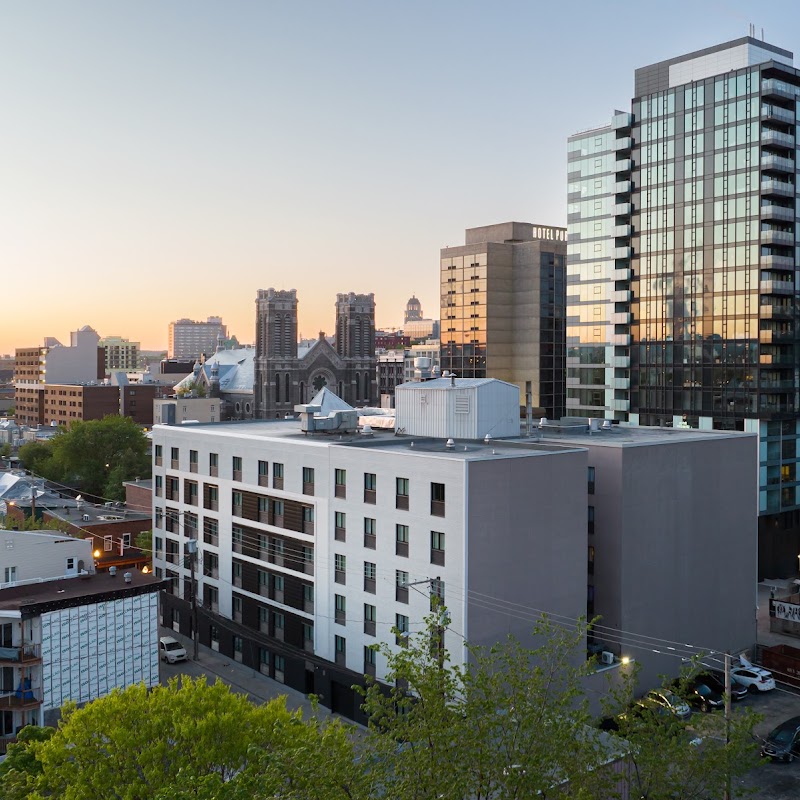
[0,0,800,353]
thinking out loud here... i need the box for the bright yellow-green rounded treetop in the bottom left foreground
[7,677,370,800]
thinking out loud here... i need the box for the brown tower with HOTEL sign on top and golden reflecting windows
[440,222,567,417]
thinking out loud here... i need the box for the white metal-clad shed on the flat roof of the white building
[395,377,519,439]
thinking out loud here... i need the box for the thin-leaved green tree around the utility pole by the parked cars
[605,661,760,800]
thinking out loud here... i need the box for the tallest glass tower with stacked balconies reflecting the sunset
[567,37,800,577]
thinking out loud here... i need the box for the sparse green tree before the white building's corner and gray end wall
[364,612,613,800]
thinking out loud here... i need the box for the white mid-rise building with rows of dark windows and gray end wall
[153,380,587,719]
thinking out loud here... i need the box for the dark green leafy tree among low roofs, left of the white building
[48,414,150,500]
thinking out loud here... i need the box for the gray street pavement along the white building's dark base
[159,627,324,718]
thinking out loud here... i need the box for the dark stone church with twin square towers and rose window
[254,289,378,419]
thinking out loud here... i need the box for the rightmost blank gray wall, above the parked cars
[589,434,758,688]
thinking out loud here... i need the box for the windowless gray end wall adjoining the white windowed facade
[465,450,587,644]
